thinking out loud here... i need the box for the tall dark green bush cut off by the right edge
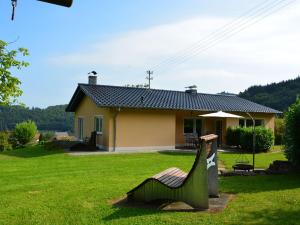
[284,98,300,165]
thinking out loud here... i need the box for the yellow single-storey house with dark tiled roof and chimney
[66,76,281,151]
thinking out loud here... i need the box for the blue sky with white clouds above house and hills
[0,0,300,107]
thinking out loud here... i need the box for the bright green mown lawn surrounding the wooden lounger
[0,146,300,225]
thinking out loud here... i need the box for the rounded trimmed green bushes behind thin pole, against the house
[226,127,274,152]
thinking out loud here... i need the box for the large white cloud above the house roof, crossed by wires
[49,1,300,92]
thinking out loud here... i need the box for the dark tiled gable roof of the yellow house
[66,84,281,113]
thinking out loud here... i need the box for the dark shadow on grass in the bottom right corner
[231,208,300,225]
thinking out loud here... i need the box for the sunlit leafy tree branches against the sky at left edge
[0,40,29,105]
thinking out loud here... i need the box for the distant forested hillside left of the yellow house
[0,105,74,131]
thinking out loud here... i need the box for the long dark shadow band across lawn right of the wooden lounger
[220,173,300,194]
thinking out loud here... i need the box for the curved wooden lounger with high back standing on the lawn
[127,134,218,209]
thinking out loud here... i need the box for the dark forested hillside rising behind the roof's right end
[239,77,300,111]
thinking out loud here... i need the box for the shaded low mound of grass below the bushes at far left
[0,145,64,158]
